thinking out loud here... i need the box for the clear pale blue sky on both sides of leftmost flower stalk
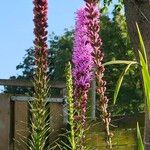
[0,0,83,79]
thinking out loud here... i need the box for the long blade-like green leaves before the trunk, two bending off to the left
[108,24,150,116]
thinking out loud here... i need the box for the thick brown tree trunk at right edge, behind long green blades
[103,0,150,150]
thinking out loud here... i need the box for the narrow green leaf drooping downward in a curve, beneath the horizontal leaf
[113,62,135,104]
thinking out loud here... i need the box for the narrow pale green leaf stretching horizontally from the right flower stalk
[103,60,137,66]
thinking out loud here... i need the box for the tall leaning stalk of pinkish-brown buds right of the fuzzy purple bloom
[84,0,112,149]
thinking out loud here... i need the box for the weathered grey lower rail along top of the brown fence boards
[11,96,65,103]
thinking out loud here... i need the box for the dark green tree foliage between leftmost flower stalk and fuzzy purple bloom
[49,30,73,81]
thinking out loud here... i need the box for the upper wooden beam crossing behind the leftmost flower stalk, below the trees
[0,79,66,88]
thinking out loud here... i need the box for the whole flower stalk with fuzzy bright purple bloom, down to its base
[72,8,93,149]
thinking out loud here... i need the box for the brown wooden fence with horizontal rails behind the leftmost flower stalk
[0,79,67,150]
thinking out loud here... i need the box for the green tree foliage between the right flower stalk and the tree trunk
[101,13,143,115]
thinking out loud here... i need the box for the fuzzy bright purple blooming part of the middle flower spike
[72,8,93,91]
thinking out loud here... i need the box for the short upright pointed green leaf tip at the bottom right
[137,122,144,150]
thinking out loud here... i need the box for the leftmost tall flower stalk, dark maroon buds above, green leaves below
[30,0,48,150]
